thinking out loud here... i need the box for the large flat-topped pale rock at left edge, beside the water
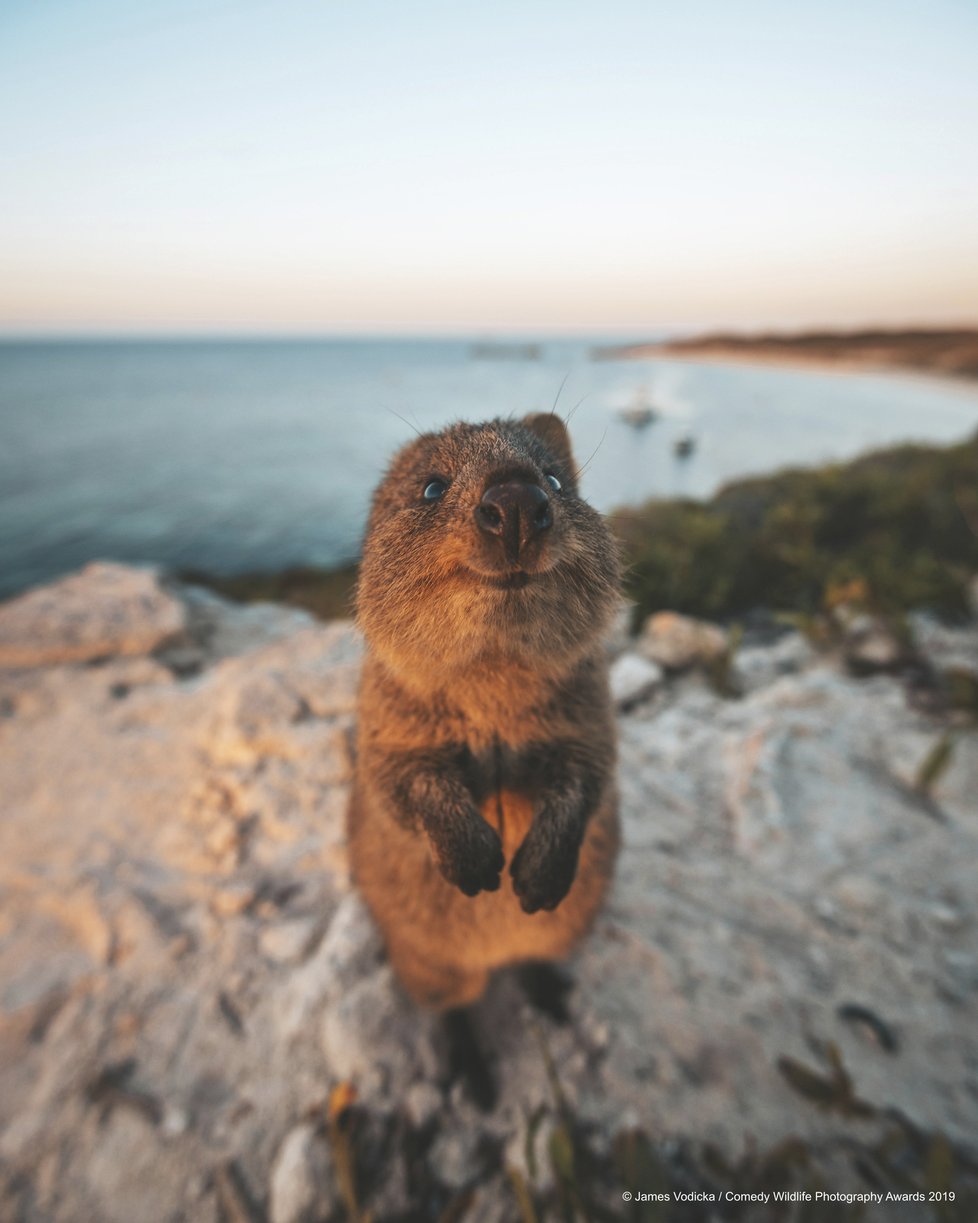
[0,561,187,667]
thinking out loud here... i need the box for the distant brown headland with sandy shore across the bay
[593,327,978,378]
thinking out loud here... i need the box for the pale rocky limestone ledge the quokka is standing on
[0,565,978,1223]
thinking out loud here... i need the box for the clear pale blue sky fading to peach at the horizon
[0,0,978,338]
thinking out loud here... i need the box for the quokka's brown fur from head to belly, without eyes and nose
[348,416,619,1008]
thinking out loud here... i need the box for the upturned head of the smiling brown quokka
[357,415,620,682]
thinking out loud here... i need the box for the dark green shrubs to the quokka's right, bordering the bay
[612,435,978,620]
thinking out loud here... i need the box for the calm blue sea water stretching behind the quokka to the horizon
[0,340,978,594]
